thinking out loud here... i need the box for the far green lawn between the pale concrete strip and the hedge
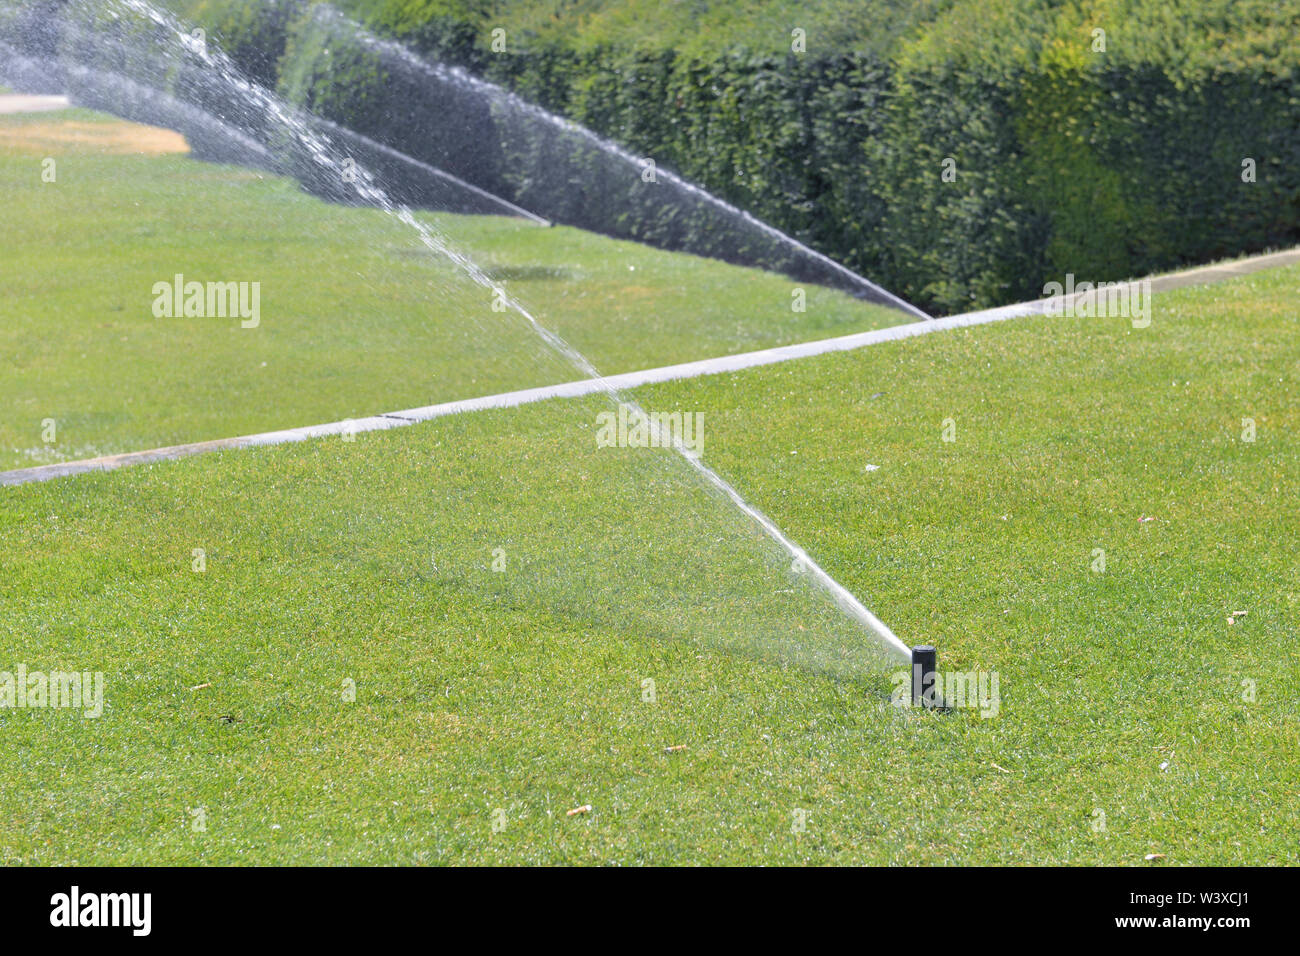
[0,111,907,470]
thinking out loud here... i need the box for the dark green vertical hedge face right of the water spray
[473,44,1300,312]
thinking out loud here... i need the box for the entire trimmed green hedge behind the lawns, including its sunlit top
[25,0,1300,311]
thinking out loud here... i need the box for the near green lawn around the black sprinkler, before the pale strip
[0,268,1300,866]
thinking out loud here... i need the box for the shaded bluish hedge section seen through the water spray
[281,7,904,298]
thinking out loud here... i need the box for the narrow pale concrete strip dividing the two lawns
[0,248,1300,485]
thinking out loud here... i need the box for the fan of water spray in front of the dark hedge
[292,4,930,319]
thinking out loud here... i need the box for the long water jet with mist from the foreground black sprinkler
[0,0,907,674]
